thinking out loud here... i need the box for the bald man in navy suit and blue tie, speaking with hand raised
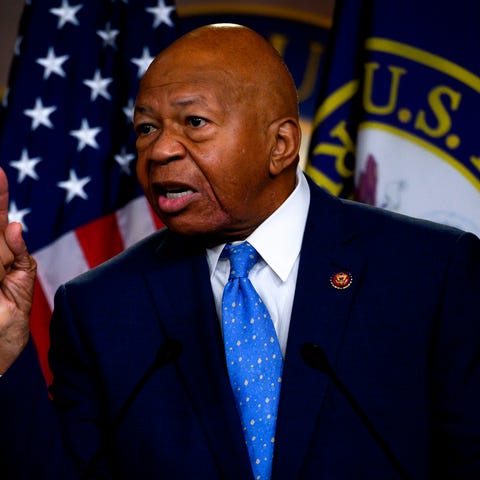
[0,25,480,480]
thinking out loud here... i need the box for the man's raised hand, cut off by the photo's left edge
[0,168,37,374]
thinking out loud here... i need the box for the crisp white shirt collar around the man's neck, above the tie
[207,167,310,281]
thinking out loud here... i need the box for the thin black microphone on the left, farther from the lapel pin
[81,338,183,479]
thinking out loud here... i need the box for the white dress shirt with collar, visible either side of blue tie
[207,168,310,355]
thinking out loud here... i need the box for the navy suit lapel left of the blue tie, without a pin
[147,235,251,479]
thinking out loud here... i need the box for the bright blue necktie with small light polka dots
[222,242,283,480]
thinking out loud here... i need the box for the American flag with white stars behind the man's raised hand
[0,0,178,382]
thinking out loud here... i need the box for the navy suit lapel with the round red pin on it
[274,182,363,478]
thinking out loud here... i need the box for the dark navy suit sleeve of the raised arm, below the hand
[0,288,109,480]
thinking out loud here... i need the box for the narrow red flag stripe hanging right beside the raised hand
[30,278,52,385]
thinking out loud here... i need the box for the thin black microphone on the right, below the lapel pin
[300,342,409,480]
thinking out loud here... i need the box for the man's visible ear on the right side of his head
[270,118,302,176]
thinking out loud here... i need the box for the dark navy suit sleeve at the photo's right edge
[430,234,480,480]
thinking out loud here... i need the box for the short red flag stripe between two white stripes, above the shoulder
[75,214,124,268]
